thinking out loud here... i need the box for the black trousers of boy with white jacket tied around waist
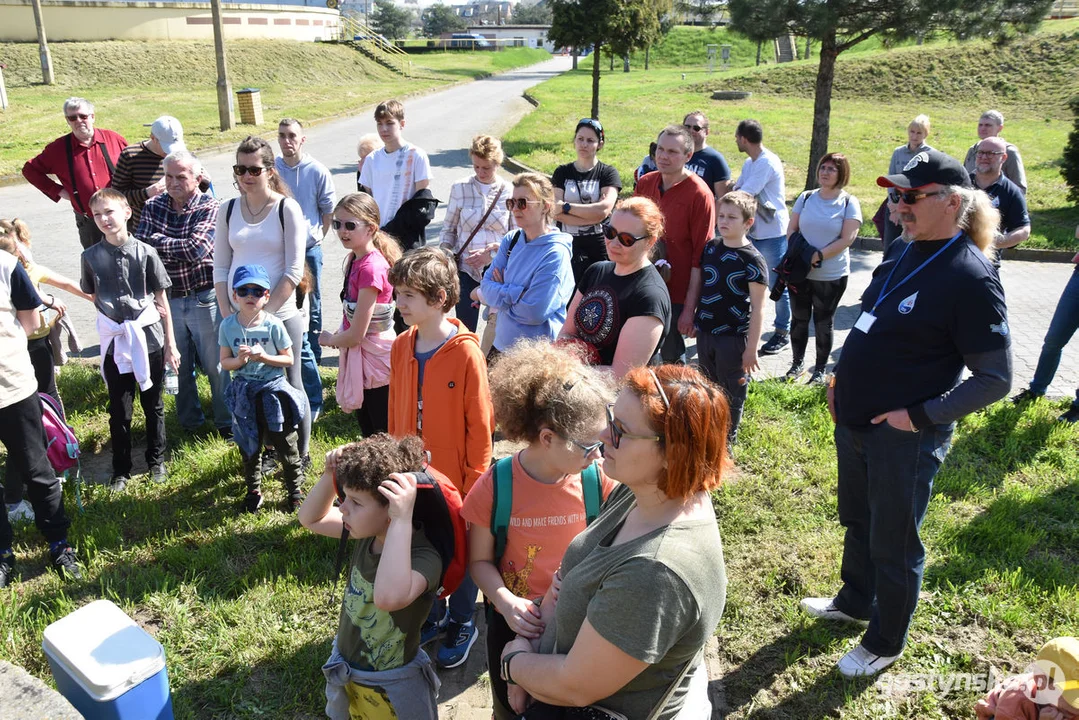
[101,350,165,476]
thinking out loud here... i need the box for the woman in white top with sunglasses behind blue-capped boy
[214,136,311,455]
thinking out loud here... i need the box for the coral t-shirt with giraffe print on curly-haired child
[461,453,615,600]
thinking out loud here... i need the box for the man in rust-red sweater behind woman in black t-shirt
[636,125,715,363]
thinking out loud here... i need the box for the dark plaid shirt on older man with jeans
[135,191,219,293]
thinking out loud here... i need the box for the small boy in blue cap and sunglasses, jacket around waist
[218,264,306,513]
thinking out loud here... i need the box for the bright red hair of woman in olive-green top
[625,365,730,500]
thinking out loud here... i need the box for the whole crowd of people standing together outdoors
[0,91,1079,720]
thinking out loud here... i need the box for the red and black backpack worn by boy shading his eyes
[330,465,468,604]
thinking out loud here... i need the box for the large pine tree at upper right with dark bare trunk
[728,0,1053,189]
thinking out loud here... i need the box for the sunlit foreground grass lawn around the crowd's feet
[0,365,1079,720]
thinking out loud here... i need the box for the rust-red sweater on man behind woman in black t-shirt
[634,172,715,304]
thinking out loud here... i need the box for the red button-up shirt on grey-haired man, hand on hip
[23,128,127,215]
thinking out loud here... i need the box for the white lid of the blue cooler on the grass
[41,600,165,701]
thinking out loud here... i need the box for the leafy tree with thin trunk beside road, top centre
[547,0,671,120]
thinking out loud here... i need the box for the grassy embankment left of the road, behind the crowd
[0,40,549,177]
